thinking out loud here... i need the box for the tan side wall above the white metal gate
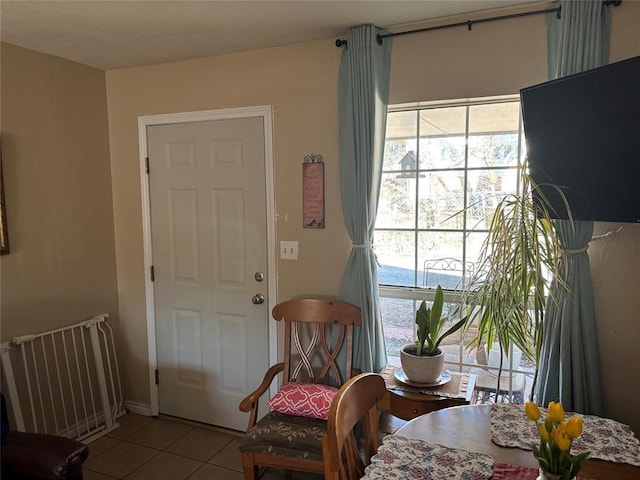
[0,44,118,341]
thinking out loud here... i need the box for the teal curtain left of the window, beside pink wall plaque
[338,25,391,372]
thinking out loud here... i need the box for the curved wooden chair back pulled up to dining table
[322,373,387,480]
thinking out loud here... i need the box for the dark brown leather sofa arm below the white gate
[2,431,89,480]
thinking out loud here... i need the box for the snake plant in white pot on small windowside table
[400,285,467,383]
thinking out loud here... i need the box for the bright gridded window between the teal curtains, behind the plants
[374,96,524,404]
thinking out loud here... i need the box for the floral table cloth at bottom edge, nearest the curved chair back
[362,435,493,480]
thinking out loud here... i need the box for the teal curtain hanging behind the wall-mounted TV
[538,0,610,415]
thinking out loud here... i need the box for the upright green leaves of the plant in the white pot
[416,285,467,356]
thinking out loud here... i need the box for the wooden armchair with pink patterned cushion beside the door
[239,298,362,480]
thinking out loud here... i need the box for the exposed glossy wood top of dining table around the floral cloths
[395,405,640,480]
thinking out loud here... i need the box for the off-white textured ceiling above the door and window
[0,0,540,70]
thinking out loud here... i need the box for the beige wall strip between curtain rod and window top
[389,7,547,104]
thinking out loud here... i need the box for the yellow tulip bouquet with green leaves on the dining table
[524,402,591,480]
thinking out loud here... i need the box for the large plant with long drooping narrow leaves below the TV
[458,171,571,400]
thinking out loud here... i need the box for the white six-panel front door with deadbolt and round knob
[146,111,269,430]
